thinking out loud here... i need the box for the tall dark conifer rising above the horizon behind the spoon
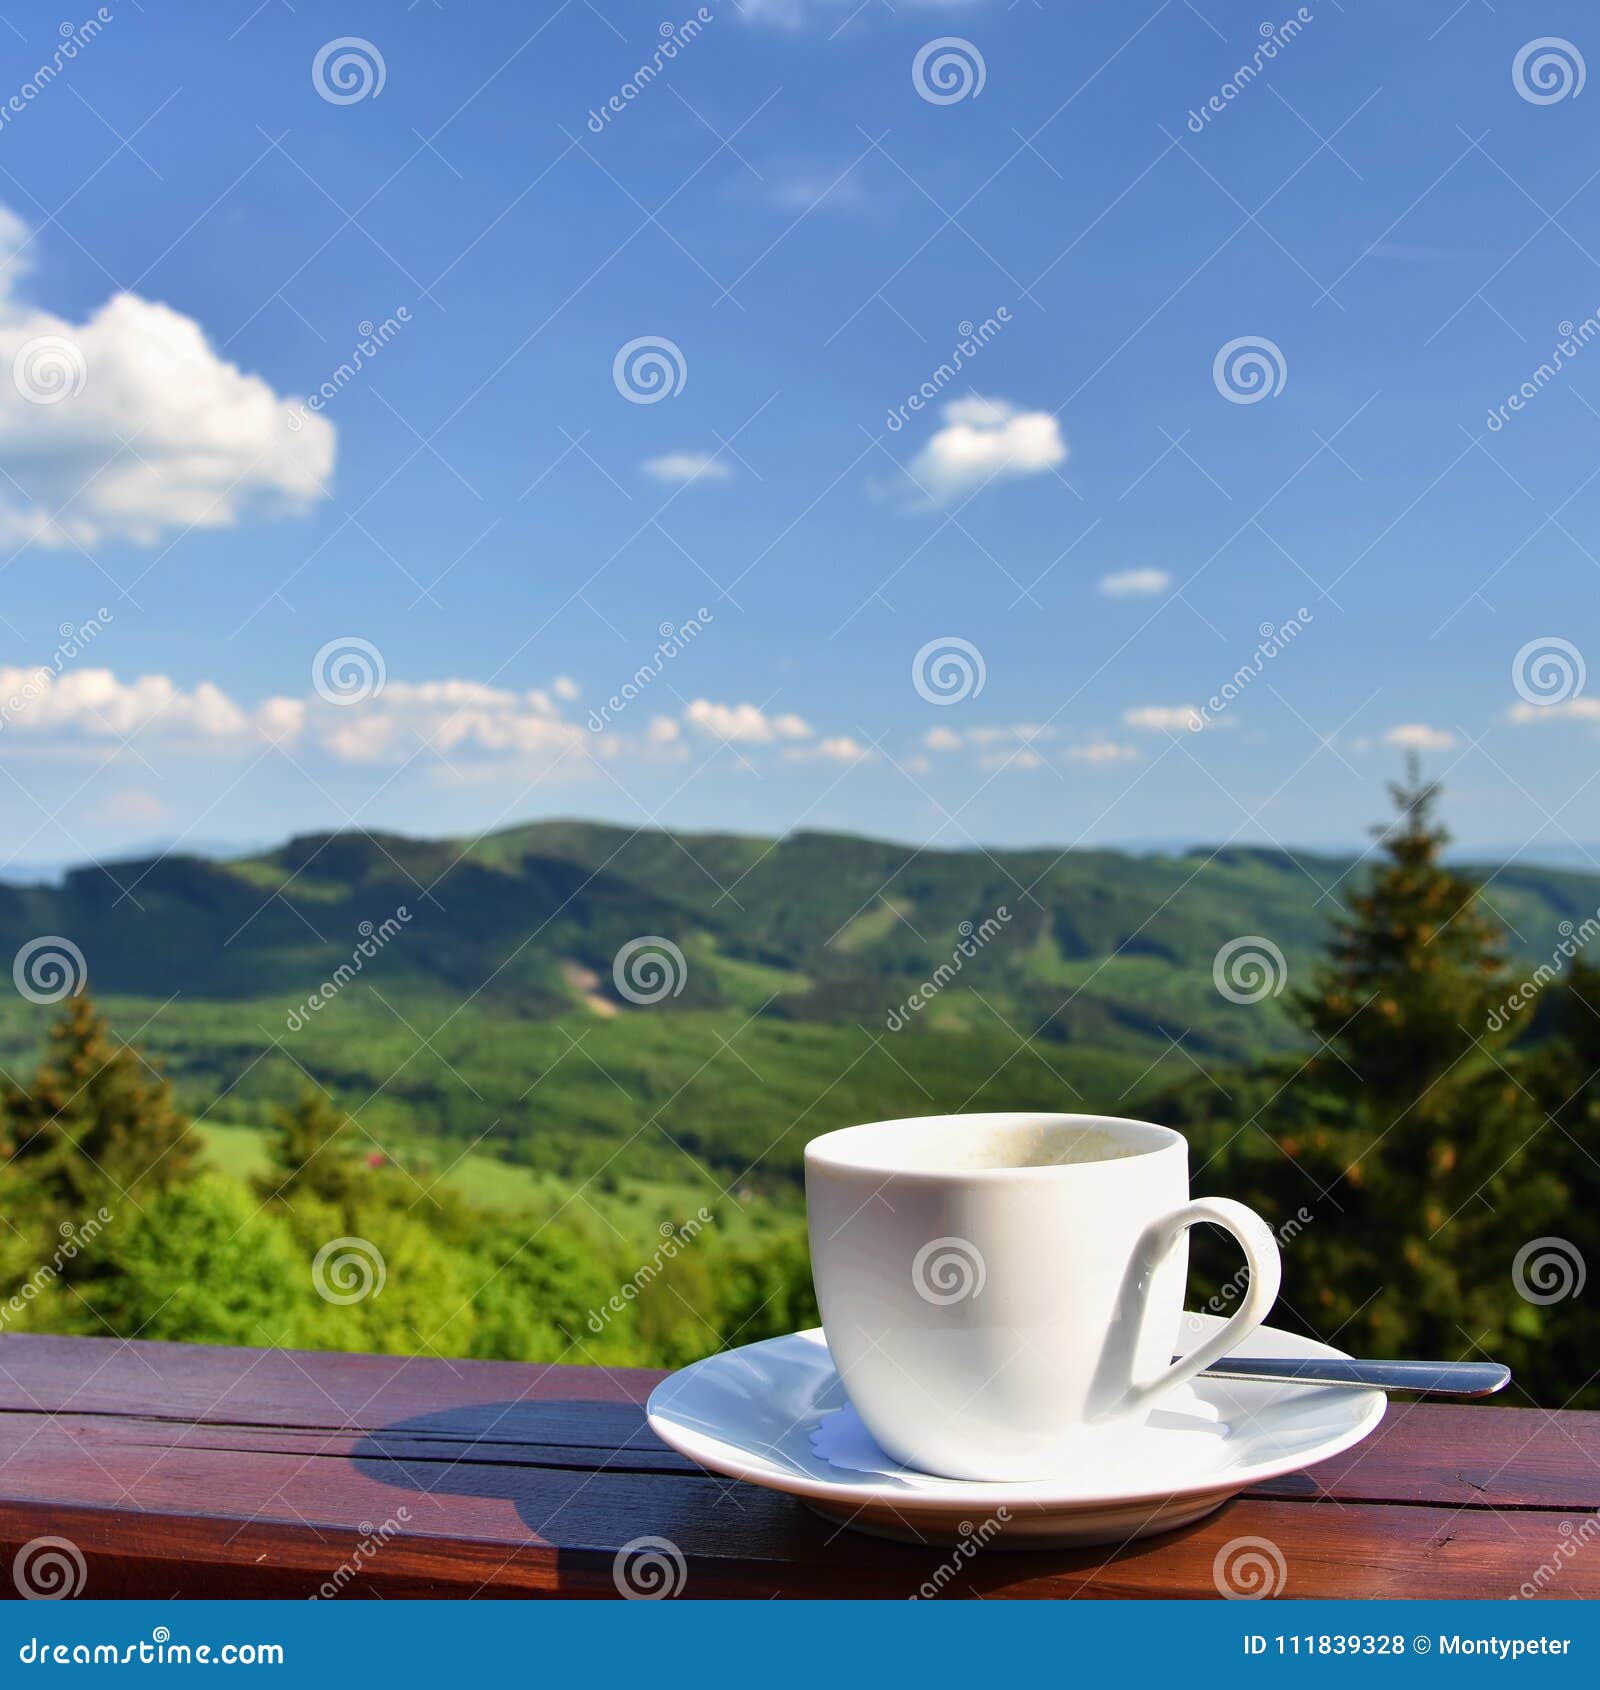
[1269,759,1561,1355]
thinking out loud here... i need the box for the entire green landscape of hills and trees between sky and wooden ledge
[0,774,1600,1408]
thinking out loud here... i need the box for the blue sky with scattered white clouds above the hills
[0,0,1600,862]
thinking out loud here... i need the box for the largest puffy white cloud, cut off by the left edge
[0,206,335,546]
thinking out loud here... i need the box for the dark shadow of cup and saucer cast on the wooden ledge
[350,1398,1223,1595]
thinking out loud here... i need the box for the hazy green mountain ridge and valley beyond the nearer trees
[0,821,1600,1191]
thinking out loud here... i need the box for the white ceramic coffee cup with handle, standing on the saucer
[806,1114,1279,1479]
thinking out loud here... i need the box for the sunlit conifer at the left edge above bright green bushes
[5,992,198,1217]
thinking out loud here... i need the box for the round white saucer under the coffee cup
[645,1315,1387,1550]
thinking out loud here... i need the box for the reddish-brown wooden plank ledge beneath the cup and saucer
[0,1335,1600,1597]
